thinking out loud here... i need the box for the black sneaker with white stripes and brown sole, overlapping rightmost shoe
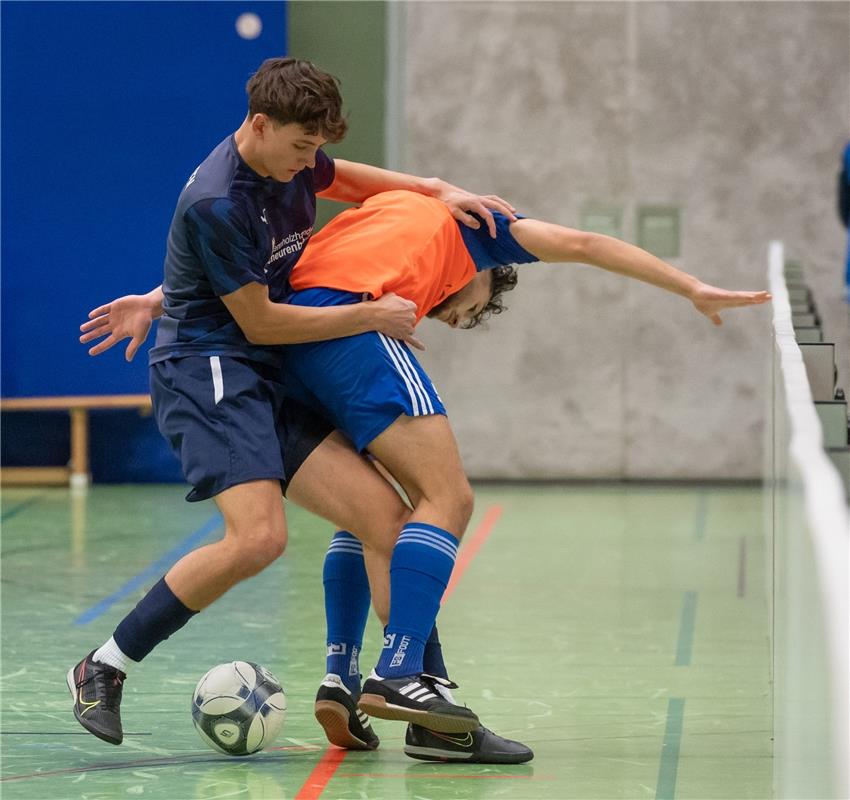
[358,672,480,733]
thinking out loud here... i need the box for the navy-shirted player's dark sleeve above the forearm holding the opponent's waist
[185,198,267,297]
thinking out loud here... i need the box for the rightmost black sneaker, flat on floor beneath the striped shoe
[404,724,534,764]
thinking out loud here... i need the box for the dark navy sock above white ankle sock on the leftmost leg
[112,578,198,661]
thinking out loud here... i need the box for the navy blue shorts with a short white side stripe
[150,356,333,501]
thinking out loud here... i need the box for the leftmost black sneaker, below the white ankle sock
[68,650,127,744]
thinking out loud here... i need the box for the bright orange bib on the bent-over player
[290,191,476,320]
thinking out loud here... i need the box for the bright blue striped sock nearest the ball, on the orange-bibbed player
[322,531,372,696]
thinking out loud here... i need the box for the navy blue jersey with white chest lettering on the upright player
[149,136,334,366]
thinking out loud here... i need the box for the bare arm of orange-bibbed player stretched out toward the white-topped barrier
[511,219,771,325]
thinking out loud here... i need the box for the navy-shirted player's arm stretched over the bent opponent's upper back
[319,158,516,238]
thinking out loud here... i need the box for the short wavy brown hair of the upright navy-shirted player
[245,58,348,142]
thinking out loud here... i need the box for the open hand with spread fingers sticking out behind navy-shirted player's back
[80,286,162,361]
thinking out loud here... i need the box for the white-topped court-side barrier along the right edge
[768,242,850,798]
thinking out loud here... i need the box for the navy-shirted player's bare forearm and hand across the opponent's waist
[221,283,425,350]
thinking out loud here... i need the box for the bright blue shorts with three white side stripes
[284,289,446,451]
